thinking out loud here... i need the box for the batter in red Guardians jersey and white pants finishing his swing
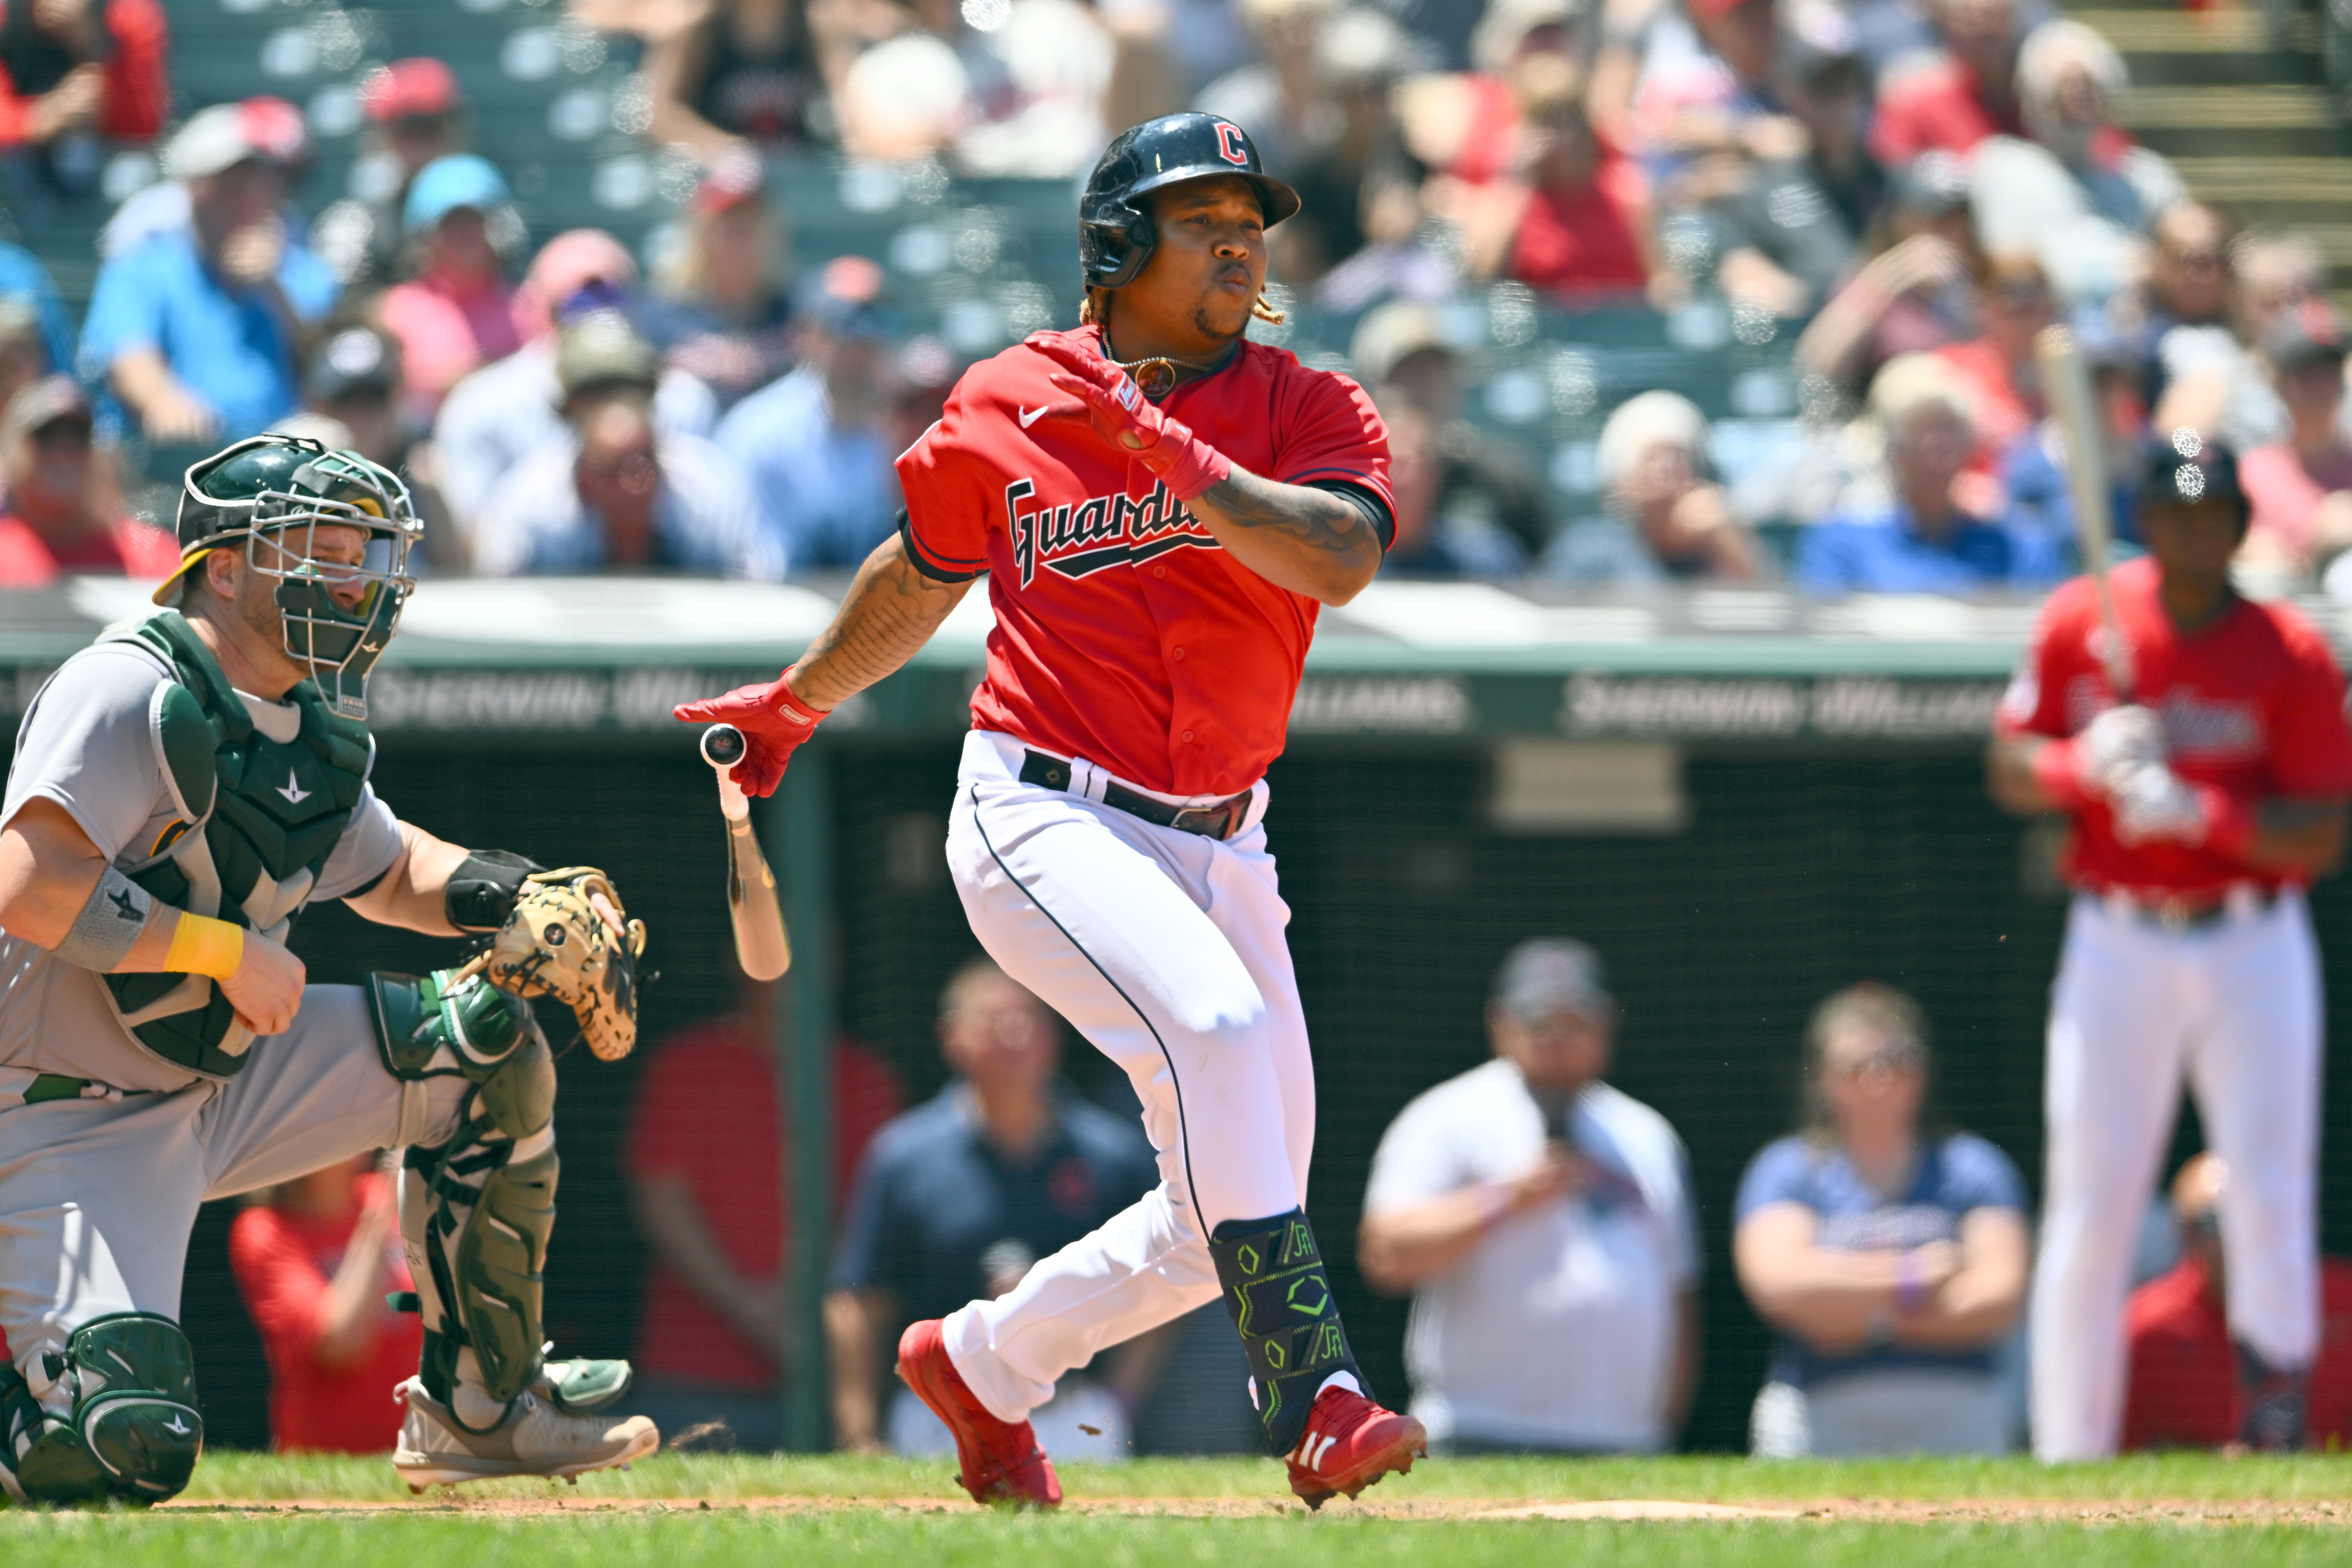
[678,115,1426,1507]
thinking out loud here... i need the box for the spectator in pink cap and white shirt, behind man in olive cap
[433,228,717,545]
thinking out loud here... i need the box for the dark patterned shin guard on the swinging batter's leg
[1209,1208,1369,1455]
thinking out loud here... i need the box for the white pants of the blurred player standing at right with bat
[2032,893,2321,1460]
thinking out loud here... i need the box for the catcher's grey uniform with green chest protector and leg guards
[0,611,626,1500]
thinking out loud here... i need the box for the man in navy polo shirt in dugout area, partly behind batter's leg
[825,957,1166,1457]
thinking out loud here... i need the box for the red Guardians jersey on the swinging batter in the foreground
[898,327,1395,797]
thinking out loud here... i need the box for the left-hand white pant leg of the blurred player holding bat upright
[2030,898,2189,1460]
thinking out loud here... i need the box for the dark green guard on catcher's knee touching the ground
[0,1311,205,1502]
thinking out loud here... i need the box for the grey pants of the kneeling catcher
[0,985,473,1391]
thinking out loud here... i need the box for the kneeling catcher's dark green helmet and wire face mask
[155,435,424,719]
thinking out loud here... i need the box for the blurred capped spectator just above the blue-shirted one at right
[1797,153,1978,397]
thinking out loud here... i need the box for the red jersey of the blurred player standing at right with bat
[1994,557,2352,893]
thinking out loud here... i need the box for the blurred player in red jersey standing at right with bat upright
[1990,430,2352,1460]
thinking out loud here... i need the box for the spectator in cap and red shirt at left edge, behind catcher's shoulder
[0,376,179,588]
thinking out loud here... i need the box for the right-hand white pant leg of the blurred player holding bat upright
[2182,896,2321,1368]
